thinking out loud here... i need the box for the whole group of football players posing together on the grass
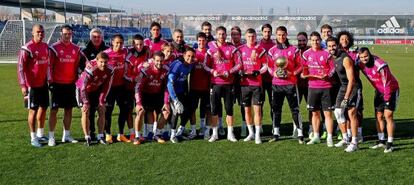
[17,22,399,153]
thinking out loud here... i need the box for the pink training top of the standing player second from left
[50,41,81,84]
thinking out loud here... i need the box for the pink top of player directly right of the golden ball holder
[302,48,335,89]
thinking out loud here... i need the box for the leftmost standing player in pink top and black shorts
[17,24,49,147]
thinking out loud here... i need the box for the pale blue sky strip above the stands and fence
[68,0,414,15]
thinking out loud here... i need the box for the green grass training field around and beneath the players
[0,46,414,184]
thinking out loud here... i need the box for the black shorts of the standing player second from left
[50,83,78,109]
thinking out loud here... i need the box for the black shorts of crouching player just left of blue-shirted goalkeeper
[142,92,164,114]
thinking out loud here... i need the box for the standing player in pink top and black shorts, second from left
[49,25,81,146]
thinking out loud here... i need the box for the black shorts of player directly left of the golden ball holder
[241,86,263,107]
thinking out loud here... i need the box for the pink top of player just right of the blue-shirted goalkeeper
[190,49,210,91]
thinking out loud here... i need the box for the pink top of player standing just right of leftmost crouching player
[104,48,128,87]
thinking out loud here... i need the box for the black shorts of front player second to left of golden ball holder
[210,84,237,116]
